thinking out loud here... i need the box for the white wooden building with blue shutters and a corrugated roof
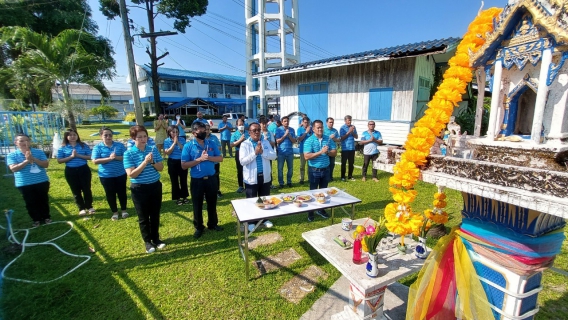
[254,38,460,145]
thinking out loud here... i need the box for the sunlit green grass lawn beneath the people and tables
[0,125,568,319]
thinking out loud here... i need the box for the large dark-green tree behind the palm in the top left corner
[0,0,115,105]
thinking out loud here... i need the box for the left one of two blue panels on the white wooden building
[298,83,328,123]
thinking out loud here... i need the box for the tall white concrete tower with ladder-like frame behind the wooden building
[245,0,300,118]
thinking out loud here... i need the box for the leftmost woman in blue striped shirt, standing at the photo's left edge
[6,133,51,227]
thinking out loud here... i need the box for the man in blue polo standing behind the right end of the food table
[304,120,337,222]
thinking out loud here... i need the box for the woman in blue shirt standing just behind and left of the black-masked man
[164,125,189,206]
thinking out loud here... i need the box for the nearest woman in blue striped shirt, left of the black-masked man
[123,126,162,253]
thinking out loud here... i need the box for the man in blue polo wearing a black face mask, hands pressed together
[181,122,223,239]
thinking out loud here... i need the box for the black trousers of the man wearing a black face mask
[189,176,219,230]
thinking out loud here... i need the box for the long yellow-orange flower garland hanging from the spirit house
[385,8,502,235]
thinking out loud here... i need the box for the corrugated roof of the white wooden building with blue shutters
[253,38,461,76]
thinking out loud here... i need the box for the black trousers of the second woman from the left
[65,165,93,210]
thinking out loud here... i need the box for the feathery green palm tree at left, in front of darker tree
[0,27,114,129]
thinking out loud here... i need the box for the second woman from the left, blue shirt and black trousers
[57,129,95,216]
